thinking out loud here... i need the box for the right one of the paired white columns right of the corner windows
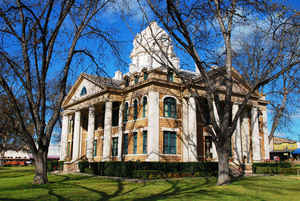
[188,97,197,161]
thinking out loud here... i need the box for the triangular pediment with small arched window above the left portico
[63,74,104,107]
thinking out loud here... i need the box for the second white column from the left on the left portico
[72,111,81,161]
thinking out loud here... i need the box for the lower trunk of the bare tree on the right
[216,143,231,185]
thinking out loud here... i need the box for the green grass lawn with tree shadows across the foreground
[0,167,300,201]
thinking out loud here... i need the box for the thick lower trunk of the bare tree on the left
[33,149,48,184]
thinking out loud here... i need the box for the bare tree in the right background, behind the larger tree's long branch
[233,13,300,142]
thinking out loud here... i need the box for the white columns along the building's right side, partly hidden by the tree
[182,97,269,162]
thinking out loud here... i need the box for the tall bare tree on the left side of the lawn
[0,0,118,184]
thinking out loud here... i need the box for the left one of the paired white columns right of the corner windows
[182,99,189,162]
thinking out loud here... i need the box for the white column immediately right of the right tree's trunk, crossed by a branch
[232,104,243,162]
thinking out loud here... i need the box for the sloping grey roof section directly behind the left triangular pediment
[82,73,123,89]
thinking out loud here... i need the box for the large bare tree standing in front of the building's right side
[138,0,299,185]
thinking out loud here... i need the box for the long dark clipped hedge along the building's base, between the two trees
[79,161,218,179]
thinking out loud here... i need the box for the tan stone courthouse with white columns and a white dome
[60,22,269,170]
